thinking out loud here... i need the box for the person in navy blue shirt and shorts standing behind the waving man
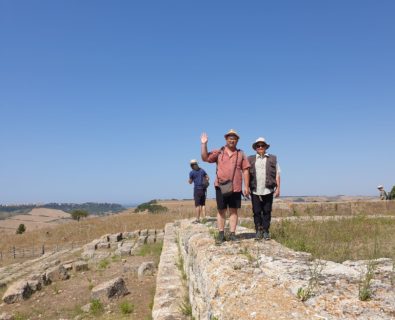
[188,159,210,223]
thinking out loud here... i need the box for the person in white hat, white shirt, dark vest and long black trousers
[248,137,280,240]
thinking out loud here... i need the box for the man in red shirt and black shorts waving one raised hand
[200,129,250,243]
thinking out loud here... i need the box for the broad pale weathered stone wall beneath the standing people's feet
[153,220,395,320]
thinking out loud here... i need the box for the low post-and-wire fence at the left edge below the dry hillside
[0,242,85,261]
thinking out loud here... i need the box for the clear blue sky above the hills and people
[0,0,395,203]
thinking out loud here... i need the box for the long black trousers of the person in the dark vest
[251,193,273,231]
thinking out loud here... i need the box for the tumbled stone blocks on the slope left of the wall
[0,230,164,304]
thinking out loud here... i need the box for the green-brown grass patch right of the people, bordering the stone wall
[244,215,395,262]
